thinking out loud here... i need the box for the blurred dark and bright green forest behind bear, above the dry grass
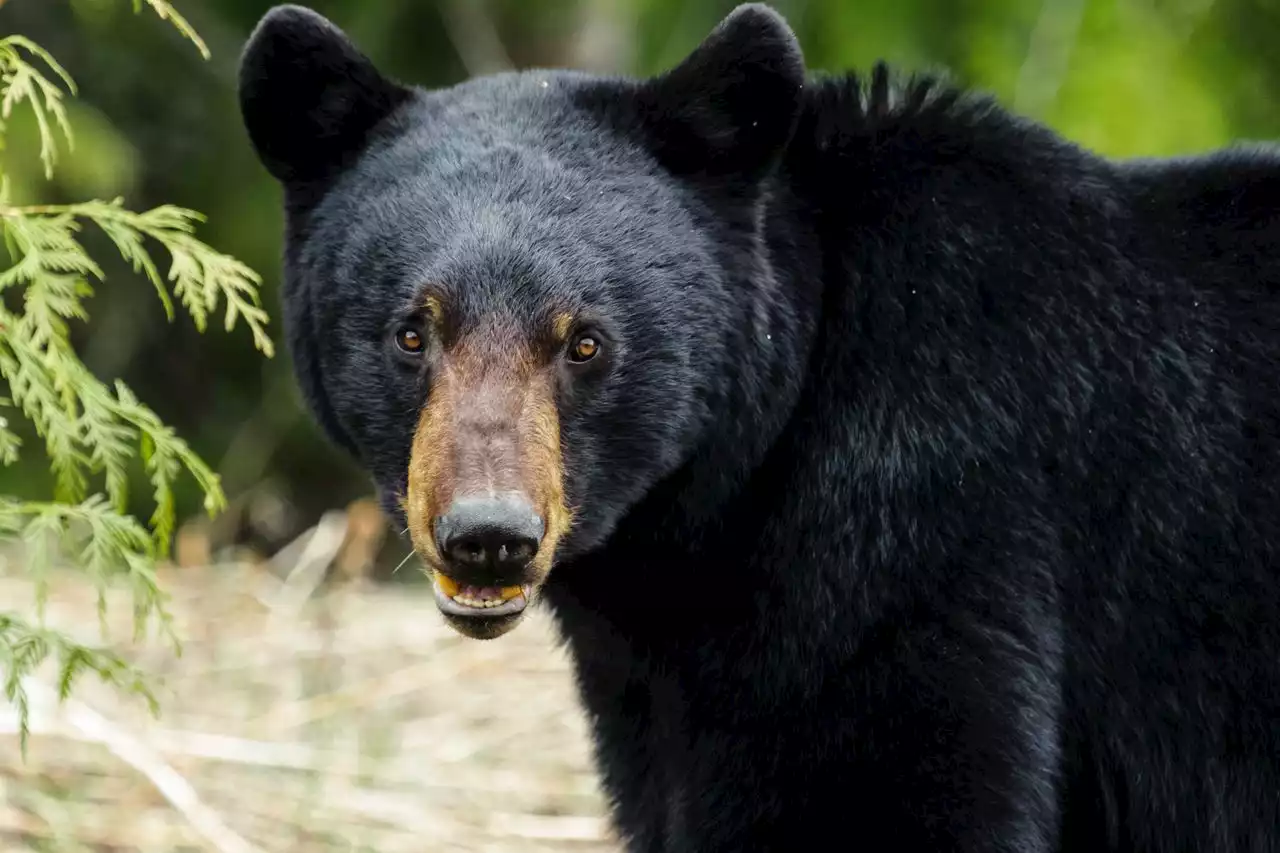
[0,0,1280,574]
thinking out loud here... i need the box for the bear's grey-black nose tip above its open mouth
[435,496,544,587]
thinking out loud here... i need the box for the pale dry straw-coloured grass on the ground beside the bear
[0,512,618,853]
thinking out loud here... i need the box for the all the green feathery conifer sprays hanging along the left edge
[0,0,271,748]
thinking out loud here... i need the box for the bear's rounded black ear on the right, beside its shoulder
[637,3,805,178]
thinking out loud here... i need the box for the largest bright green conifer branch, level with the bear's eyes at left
[0,194,274,545]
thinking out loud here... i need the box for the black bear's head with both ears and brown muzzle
[241,6,803,637]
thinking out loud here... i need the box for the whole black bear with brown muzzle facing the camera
[241,5,1280,853]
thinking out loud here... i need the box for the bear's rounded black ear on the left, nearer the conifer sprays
[239,5,410,183]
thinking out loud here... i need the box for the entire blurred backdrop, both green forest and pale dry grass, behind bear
[0,0,1280,850]
